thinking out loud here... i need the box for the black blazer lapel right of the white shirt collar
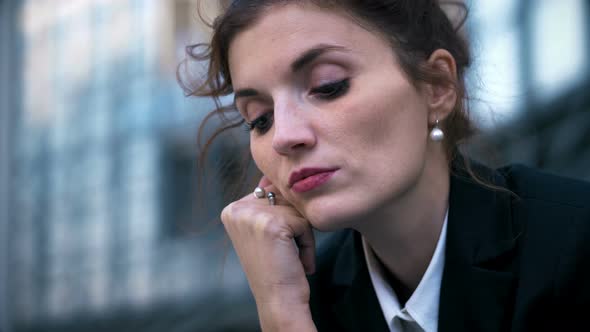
[439,163,522,332]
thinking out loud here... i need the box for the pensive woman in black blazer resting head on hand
[183,0,590,331]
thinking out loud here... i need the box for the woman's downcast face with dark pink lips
[229,5,440,230]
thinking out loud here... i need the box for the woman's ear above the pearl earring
[426,49,457,123]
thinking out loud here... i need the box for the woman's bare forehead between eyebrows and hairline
[229,4,390,85]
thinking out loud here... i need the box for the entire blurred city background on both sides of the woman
[0,0,590,332]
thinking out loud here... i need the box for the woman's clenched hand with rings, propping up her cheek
[221,177,315,331]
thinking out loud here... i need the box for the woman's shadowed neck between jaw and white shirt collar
[356,152,450,294]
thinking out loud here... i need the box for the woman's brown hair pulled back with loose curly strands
[178,0,490,201]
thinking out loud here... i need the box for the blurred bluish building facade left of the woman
[3,0,254,331]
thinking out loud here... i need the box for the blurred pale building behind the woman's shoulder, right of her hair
[469,0,590,180]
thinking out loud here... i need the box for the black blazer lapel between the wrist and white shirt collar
[332,232,396,332]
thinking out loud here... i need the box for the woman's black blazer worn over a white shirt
[309,162,590,332]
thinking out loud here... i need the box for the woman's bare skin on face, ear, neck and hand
[222,4,456,331]
